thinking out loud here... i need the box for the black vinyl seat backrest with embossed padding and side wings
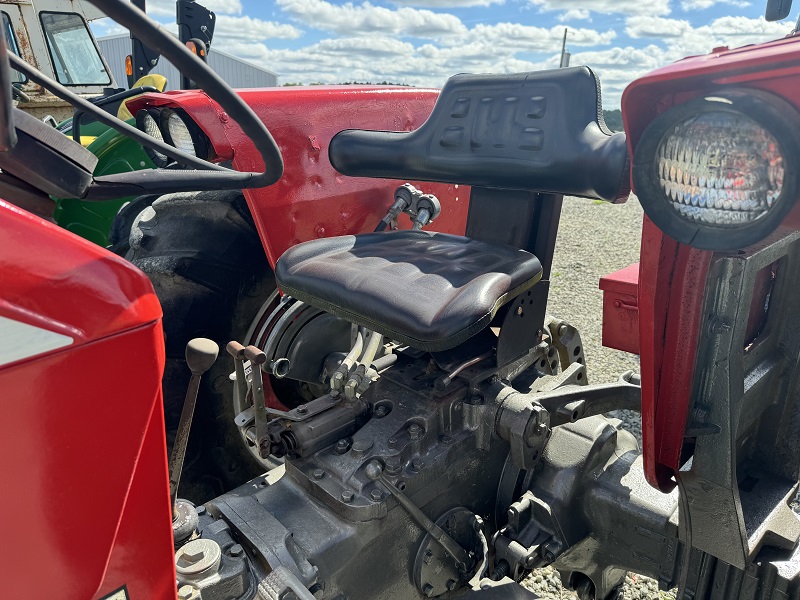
[329,67,630,201]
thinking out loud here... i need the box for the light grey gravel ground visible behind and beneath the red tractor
[523,197,675,600]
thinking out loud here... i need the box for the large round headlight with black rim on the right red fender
[633,90,800,250]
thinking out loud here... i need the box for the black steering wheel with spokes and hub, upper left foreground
[0,0,283,200]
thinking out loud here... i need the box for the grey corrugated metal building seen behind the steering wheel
[97,33,278,90]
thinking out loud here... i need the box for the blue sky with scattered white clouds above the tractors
[95,0,800,109]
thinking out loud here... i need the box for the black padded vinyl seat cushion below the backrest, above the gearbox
[275,231,542,352]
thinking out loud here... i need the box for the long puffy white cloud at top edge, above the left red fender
[276,0,467,39]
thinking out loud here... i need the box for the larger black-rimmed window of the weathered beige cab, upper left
[41,12,111,85]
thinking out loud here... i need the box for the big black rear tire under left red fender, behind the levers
[127,191,276,502]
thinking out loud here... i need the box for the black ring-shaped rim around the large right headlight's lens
[632,90,800,251]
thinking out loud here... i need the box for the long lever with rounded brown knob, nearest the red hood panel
[169,338,219,544]
